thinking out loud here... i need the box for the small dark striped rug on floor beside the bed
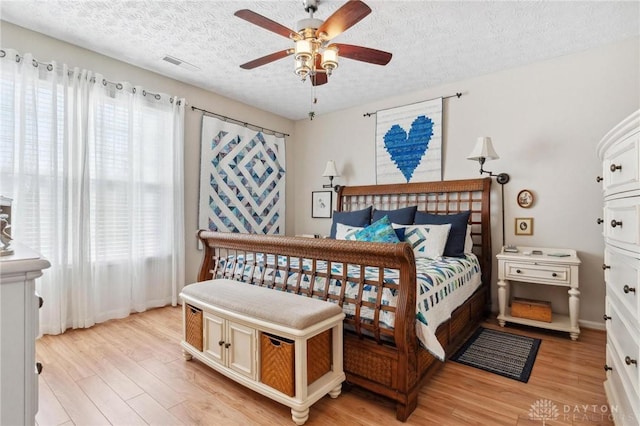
[451,327,541,383]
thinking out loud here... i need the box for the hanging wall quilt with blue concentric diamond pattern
[198,115,285,234]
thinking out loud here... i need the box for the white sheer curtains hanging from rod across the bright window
[0,49,185,334]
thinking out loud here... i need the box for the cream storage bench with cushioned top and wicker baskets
[180,279,345,425]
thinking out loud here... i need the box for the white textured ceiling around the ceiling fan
[0,0,640,119]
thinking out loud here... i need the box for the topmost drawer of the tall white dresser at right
[602,133,640,194]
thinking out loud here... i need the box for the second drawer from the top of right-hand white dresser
[602,197,640,245]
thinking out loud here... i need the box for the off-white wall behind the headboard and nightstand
[294,38,640,325]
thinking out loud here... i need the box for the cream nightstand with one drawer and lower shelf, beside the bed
[496,247,580,340]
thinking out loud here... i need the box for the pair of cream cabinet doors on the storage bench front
[203,312,258,380]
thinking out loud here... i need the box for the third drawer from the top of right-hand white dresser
[604,246,640,323]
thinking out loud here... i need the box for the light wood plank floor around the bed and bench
[36,307,613,426]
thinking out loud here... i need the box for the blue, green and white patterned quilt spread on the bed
[217,254,481,360]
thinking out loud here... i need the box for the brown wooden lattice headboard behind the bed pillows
[337,177,492,285]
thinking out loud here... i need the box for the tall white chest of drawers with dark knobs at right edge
[597,111,640,425]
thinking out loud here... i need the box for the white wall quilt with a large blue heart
[376,98,442,184]
